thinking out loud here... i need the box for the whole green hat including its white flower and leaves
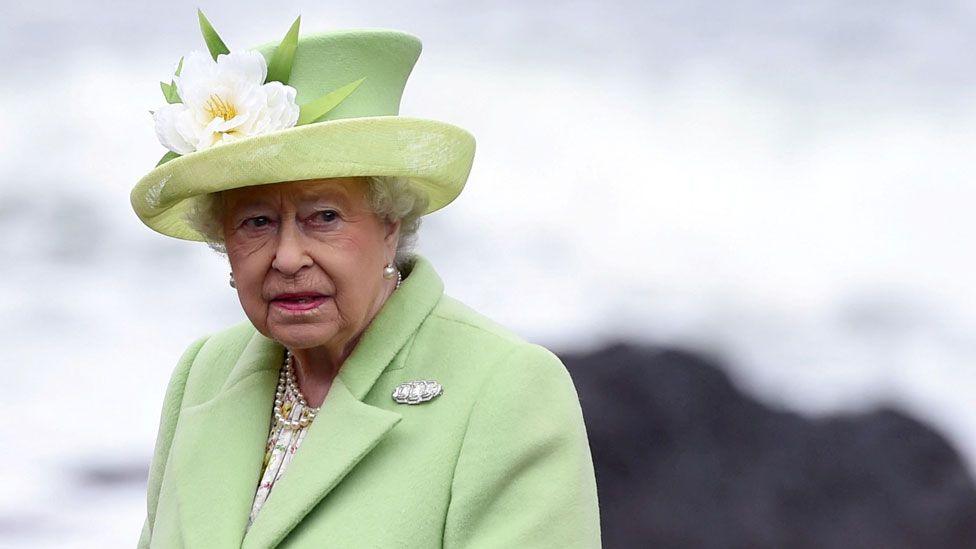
[130,12,475,241]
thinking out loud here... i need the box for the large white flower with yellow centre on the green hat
[153,50,300,154]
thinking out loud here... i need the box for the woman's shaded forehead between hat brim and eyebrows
[224,177,365,207]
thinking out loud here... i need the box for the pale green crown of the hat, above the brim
[251,28,422,122]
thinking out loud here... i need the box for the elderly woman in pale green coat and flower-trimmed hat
[132,17,600,549]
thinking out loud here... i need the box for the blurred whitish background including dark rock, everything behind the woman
[0,0,976,547]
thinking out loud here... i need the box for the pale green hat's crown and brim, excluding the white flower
[130,12,475,241]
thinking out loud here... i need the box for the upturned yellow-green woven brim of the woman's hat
[130,115,475,241]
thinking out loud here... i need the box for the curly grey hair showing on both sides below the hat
[184,175,428,268]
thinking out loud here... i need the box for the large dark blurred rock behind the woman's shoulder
[561,344,976,549]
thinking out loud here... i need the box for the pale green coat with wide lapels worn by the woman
[139,256,600,549]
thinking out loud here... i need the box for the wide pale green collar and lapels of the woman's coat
[170,256,444,548]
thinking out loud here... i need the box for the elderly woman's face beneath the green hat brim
[222,177,399,352]
